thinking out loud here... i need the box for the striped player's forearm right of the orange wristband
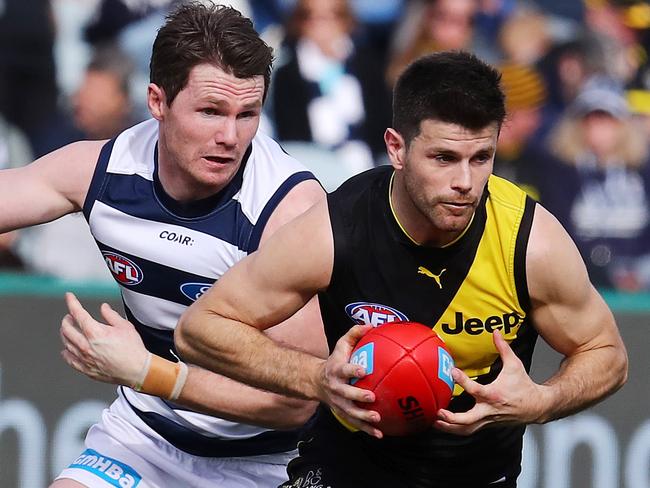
[176,366,317,429]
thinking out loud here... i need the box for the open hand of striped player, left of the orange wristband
[60,293,149,386]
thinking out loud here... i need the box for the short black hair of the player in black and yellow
[393,51,506,145]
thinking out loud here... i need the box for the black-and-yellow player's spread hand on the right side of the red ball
[434,331,544,435]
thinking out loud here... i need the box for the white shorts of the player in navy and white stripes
[56,402,297,488]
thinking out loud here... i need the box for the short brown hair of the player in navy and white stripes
[149,2,273,105]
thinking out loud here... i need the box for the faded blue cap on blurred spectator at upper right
[569,76,630,119]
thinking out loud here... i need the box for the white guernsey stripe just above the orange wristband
[122,287,187,330]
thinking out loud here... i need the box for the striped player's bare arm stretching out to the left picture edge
[0,141,106,233]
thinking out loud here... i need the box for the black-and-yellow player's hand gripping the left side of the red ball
[312,325,383,439]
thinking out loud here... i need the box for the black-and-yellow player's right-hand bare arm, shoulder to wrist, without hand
[527,205,627,422]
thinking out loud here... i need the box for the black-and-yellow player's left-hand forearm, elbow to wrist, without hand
[174,310,325,400]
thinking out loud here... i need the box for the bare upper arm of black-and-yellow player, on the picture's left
[195,199,334,329]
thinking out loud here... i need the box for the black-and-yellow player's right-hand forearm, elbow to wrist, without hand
[538,345,627,423]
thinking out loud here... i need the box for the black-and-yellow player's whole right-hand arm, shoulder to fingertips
[436,205,627,434]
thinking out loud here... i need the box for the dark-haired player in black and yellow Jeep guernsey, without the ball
[176,52,627,488]
